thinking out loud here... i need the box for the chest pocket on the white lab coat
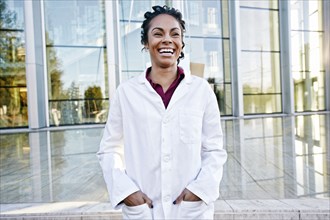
[179,110,203,144]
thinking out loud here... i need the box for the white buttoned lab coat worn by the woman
[97,68,227,219]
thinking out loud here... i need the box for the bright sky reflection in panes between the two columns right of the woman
[239,6,280,92]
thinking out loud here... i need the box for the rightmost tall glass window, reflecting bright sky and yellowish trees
[290,0,325,112]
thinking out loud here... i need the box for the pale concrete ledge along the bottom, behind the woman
[0,199,330,220]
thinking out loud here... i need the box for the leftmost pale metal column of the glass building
[24,1,48,129]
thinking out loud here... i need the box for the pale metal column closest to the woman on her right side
[228,1,244,117]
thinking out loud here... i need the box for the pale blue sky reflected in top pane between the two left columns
[45,1,105,46]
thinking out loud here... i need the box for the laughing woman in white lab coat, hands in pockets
[97,6,227,219]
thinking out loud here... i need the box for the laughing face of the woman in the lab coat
[145,14,182,68]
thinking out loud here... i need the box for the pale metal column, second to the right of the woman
[278,1,295,115]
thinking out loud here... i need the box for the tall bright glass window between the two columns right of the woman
[240,1,282,114]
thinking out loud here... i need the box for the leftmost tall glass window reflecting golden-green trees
[0,1,28,128]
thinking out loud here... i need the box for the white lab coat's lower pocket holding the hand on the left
[122,203,152,219]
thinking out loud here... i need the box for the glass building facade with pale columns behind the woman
[0,0,330,129]
